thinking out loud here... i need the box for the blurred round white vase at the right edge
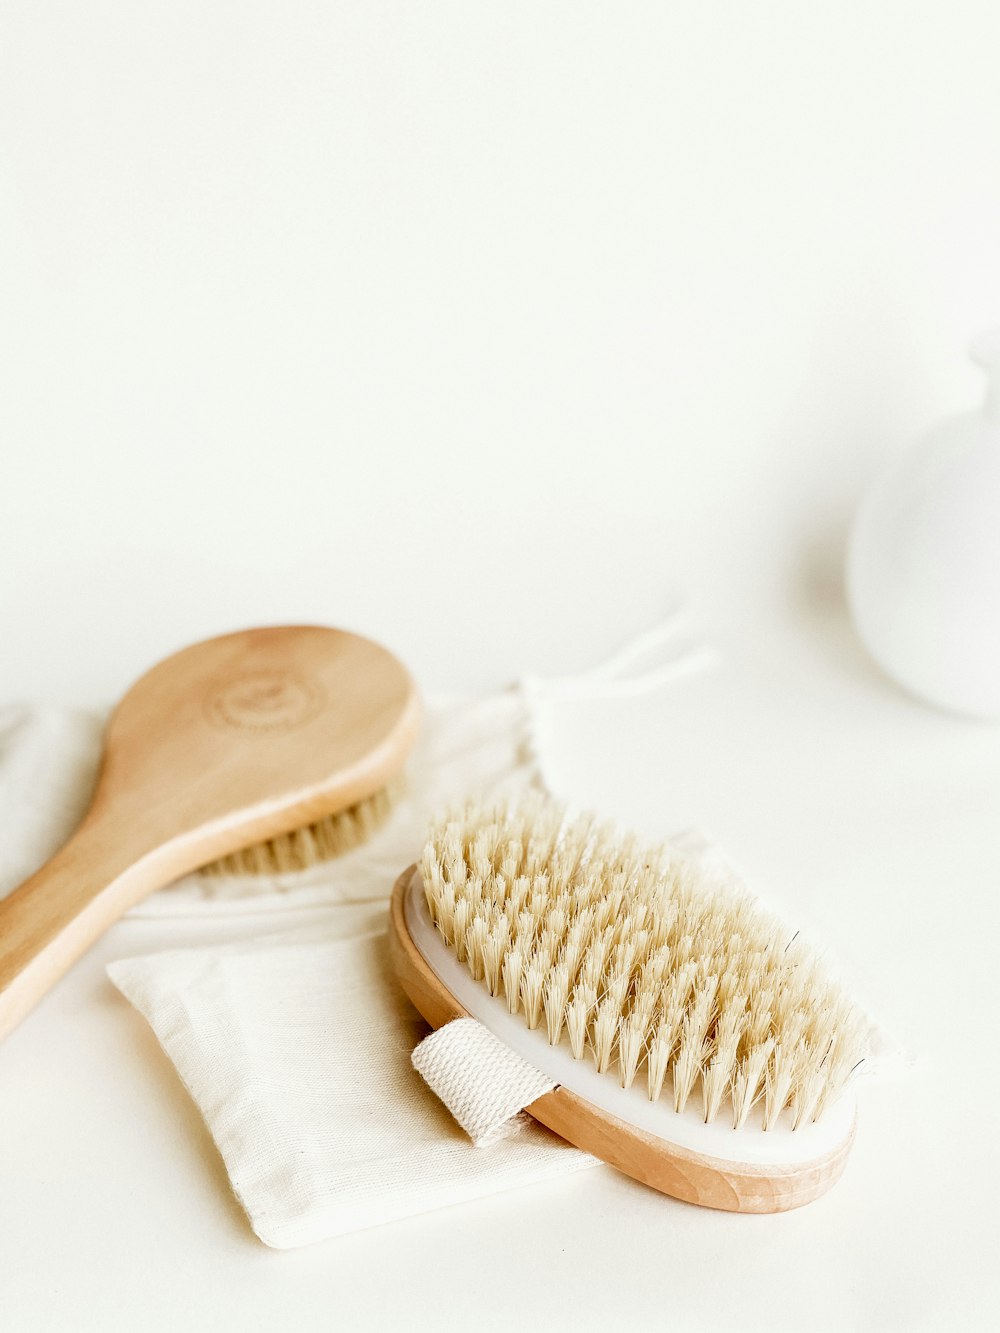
[847,329,1000,718]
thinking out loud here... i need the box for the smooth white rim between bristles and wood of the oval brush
[404,869,855,1166]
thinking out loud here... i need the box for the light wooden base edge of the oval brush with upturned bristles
[389,866,855,1213]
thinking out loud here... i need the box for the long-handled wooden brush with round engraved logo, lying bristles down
[0,625,419,1036]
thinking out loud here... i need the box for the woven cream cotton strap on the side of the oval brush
[412,1018,556,1148]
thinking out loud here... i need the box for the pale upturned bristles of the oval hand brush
[420,796,869,1129]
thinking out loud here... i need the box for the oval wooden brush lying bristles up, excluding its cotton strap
[389,797,871,1213]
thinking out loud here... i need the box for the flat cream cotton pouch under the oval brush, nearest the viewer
[108,909,593,1249]
